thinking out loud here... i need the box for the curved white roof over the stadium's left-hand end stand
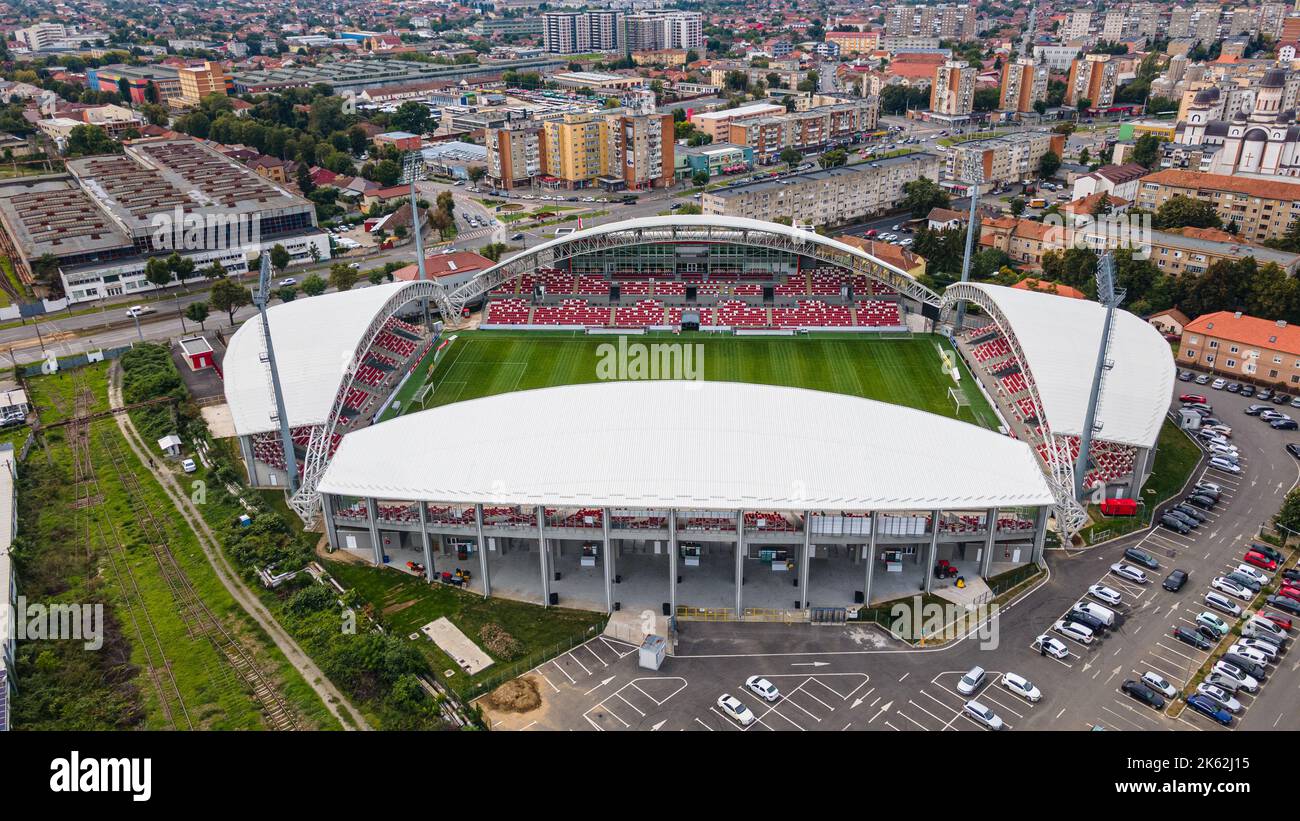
[222,282,408,436]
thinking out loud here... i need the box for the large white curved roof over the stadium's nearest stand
[319,381,1053,511]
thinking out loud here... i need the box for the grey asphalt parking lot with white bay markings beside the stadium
[483,371,1300,731]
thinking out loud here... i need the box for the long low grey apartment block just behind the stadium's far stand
[701,152,940,225]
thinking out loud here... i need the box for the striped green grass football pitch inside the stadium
[385,331,997,429]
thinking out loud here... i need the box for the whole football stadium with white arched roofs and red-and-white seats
[224,216,1174,618]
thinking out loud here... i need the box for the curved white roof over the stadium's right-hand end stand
[972,283,1174,448]
